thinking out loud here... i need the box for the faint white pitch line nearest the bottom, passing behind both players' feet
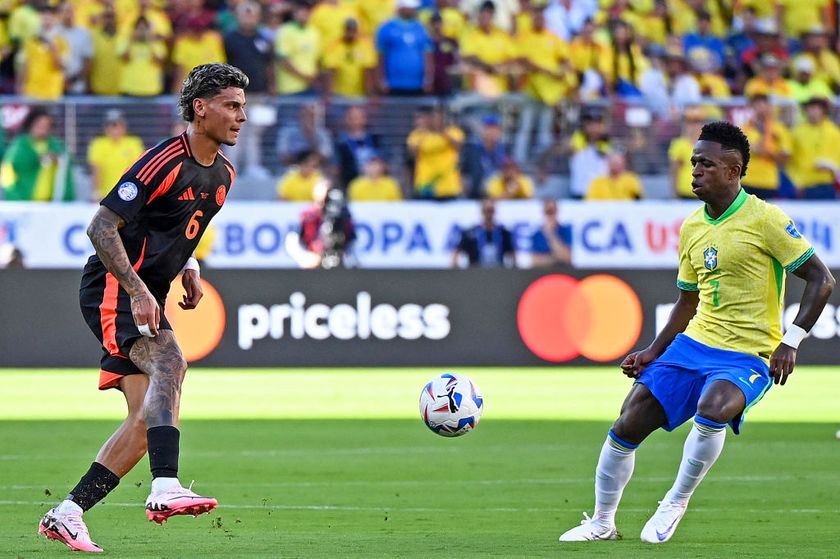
[0,501,840,514]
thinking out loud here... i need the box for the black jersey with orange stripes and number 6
[87,133,236,301]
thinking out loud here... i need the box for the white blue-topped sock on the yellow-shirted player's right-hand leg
[665,416,726,504]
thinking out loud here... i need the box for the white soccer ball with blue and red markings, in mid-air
[420,373,484,437]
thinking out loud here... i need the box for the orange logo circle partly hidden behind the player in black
[164,276,225,363]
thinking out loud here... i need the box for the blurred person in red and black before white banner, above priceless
[285,180,356,270]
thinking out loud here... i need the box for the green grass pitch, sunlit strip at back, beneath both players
[0,367,840,559]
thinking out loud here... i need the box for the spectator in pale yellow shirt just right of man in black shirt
[274,0,323,95]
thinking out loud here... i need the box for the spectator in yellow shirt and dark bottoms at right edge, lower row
[789,97,840,200]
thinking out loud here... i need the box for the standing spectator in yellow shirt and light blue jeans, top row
[514,1,577,162]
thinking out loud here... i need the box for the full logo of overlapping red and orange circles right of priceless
[517,274,643,362]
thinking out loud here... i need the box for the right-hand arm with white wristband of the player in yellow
[770,254,835,384]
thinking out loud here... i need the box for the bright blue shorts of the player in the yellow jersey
[636,334,773,435]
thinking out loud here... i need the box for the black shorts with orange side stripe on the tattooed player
[79,263,172,390]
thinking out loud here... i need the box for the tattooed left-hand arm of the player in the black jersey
[87,206,160,336]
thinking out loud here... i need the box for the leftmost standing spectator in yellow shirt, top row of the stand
[18,6,70,100]
